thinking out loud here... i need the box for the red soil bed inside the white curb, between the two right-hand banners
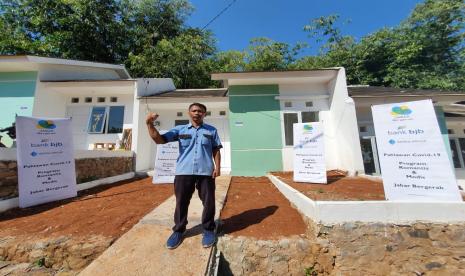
[273,171,385,201]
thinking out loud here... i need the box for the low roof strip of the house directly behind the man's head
[140,88,228,99]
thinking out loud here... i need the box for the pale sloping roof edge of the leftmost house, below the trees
[0,55,131,79]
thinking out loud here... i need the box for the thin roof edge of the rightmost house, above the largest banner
[347,85,465,98]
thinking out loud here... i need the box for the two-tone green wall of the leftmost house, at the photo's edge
[0,72,37,147]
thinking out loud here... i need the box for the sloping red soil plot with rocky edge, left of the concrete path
[0,178,173,275]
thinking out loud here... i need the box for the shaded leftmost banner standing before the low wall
[16,116,77,208]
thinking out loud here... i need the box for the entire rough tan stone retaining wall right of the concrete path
[218,223,465,275]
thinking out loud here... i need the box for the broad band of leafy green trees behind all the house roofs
[0,0,465,90]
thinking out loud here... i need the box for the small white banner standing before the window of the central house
[294,123,327,184]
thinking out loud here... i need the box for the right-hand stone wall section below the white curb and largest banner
[318,223,465,275]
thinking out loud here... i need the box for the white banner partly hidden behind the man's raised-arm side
[152,138,179,184]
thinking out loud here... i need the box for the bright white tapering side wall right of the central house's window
[325,68,364,172]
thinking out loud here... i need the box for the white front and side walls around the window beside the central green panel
[279,69,364,173]
